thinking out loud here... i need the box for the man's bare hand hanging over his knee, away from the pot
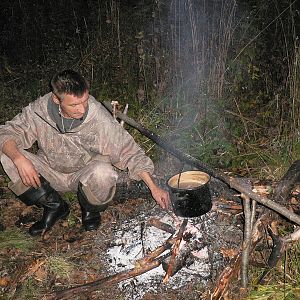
[14,156,41,188]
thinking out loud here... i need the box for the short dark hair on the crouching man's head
[50,70,89,100]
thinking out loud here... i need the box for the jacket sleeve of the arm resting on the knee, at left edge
[0,104,36,153]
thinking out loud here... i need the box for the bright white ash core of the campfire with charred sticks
[108,209,208,283]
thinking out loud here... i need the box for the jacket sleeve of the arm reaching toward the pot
[100,119,154,180]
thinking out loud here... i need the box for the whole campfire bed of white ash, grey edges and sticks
[99,208,241,300]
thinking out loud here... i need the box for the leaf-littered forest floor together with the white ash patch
[0,163,298,300]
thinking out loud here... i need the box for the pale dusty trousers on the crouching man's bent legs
[1,150,118,205]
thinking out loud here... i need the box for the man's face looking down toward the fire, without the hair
[52,91,89,119]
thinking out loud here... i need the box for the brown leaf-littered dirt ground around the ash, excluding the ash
[0,166,253,300]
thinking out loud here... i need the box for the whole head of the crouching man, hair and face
[50,70,89,119]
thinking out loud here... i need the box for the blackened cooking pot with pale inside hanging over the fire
[167,171,212,218]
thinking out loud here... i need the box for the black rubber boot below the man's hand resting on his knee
[18,177,70,236]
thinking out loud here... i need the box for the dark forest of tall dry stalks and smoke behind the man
[0,0,300,179]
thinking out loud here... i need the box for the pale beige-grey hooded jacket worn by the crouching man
[0,93,153,180]
